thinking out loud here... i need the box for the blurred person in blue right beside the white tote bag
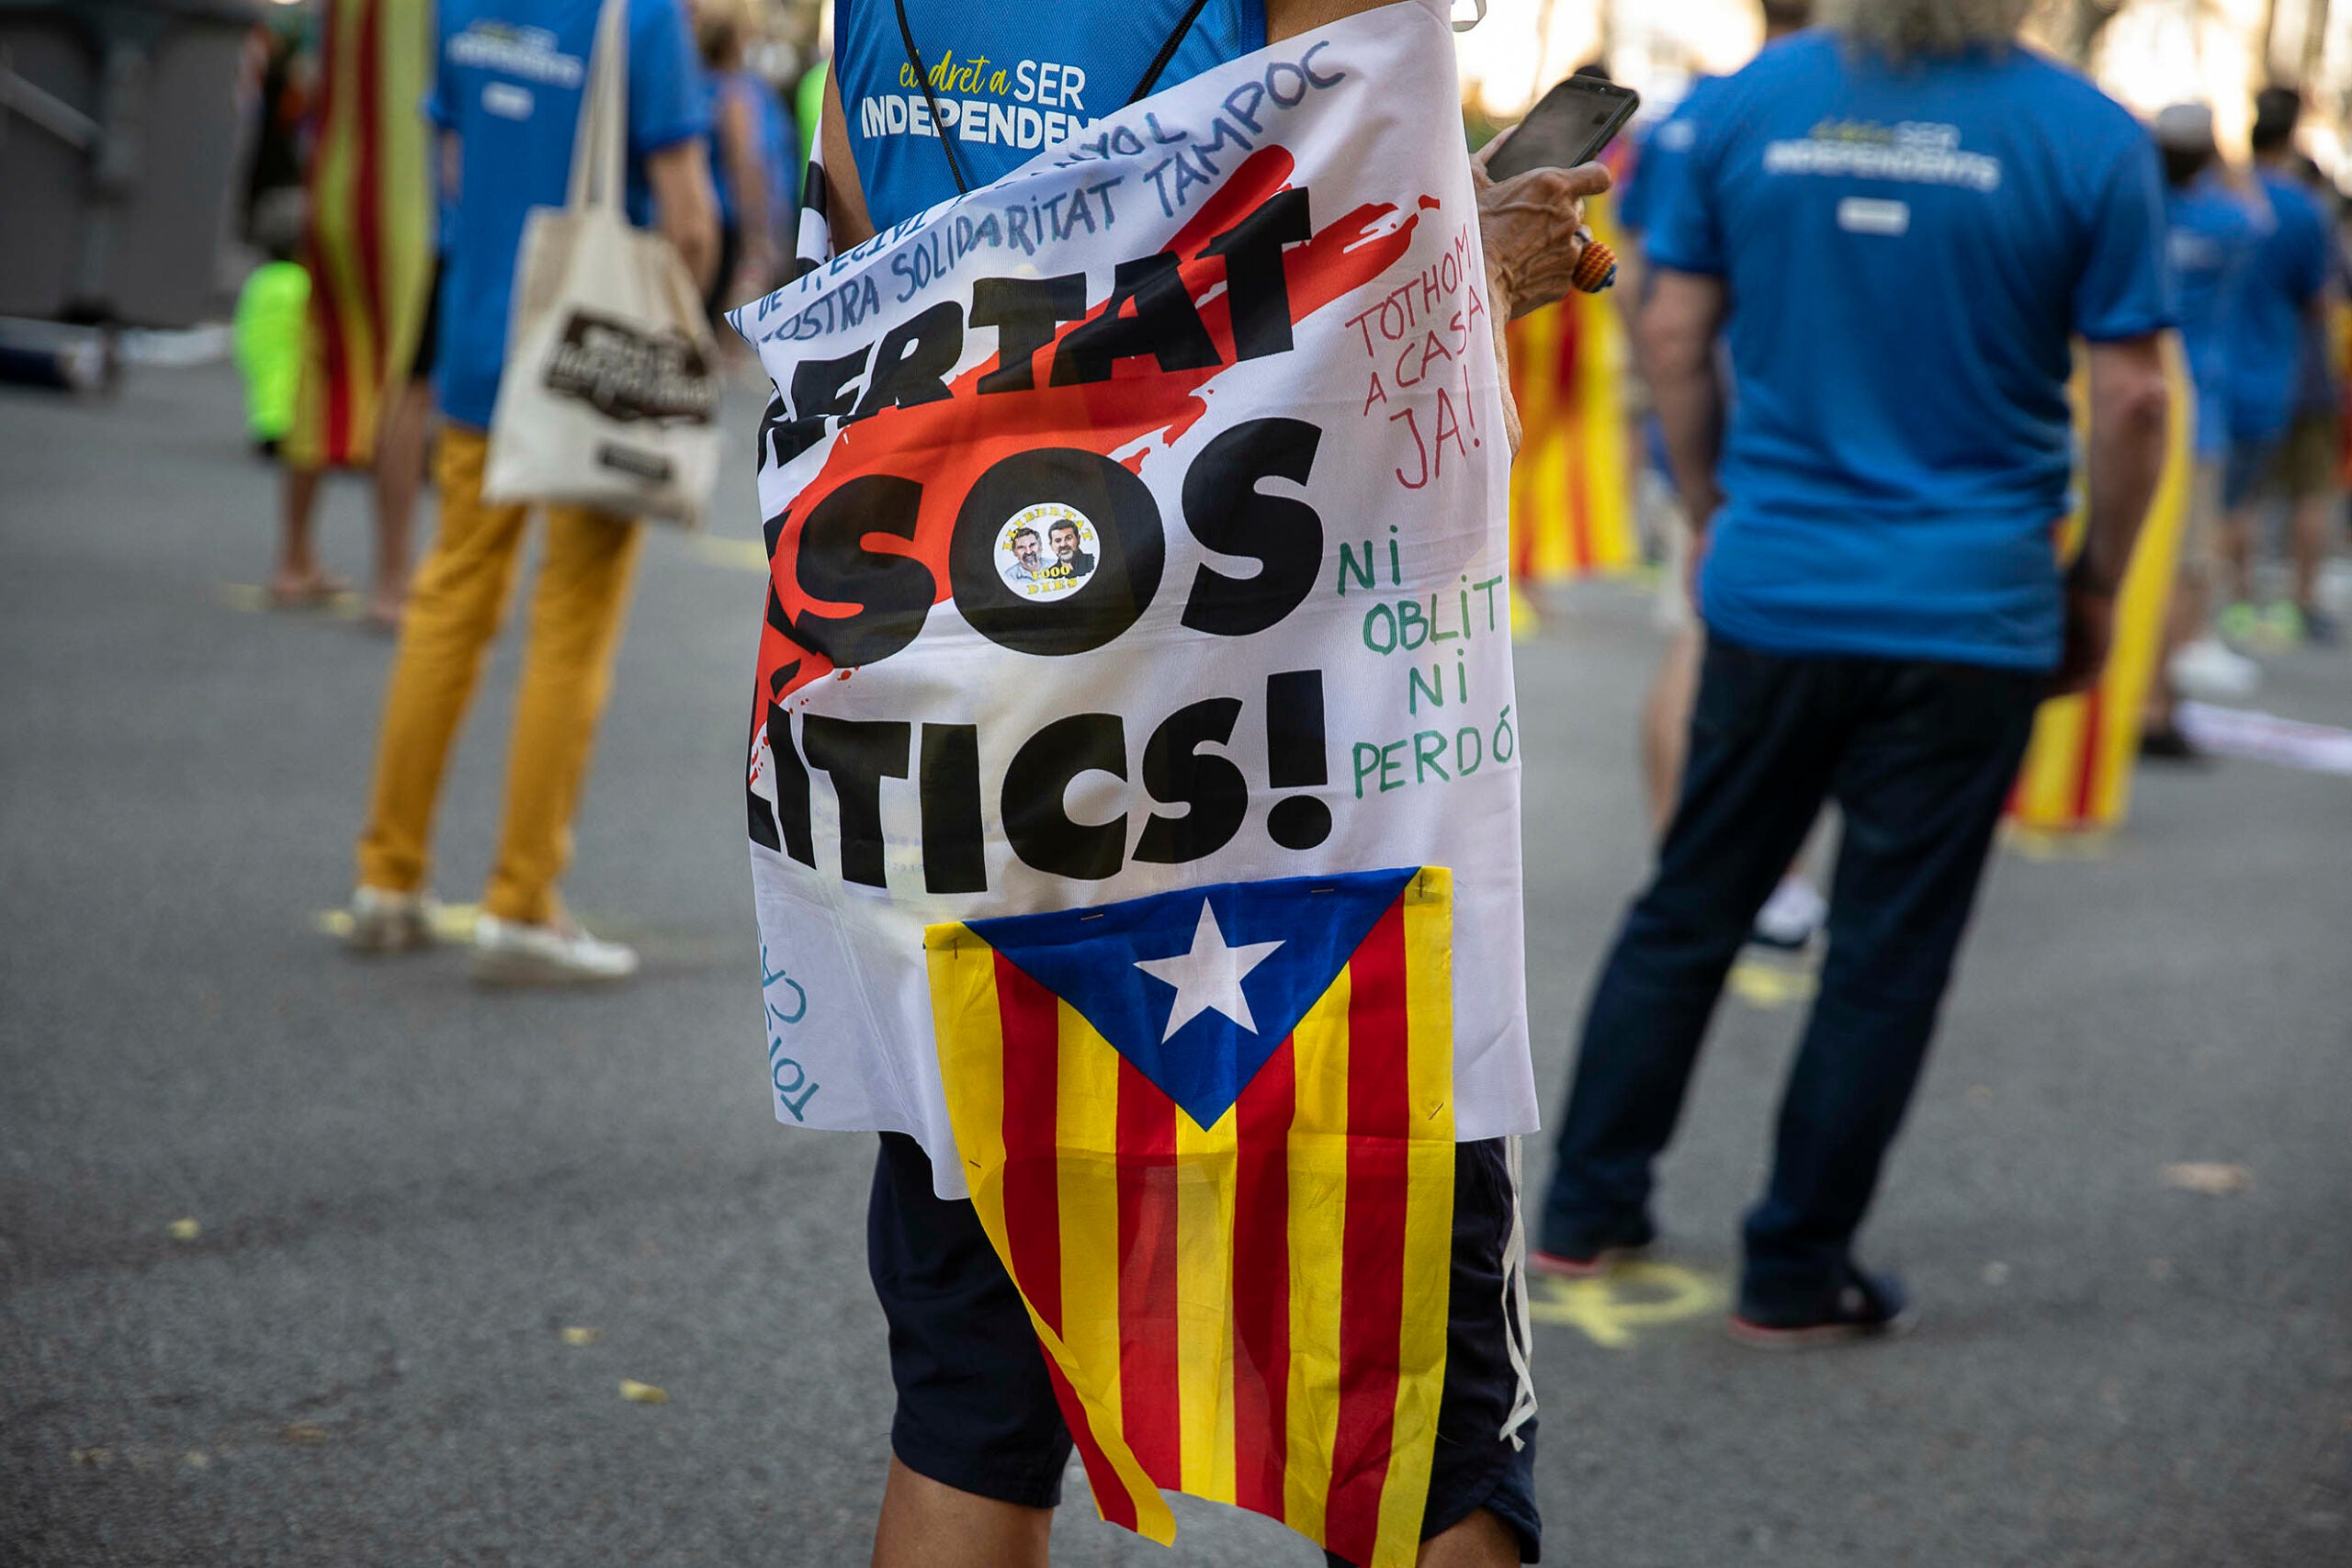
[694,0,799,321]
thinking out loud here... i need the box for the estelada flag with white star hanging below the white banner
[924,867,1453,1568]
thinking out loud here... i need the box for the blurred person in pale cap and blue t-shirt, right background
[2141,104,2267,761]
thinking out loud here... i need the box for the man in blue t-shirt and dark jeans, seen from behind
[1541,0,2173,1345]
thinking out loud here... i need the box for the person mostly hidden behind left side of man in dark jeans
[1616,0,1830,947]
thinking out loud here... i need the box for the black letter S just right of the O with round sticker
[1183,419,1322,637]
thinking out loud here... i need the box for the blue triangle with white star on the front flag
[967,867,1419,1128]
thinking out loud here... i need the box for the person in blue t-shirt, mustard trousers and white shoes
[350,0,718,983]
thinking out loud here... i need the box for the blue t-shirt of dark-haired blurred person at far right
[2230,169,2328,442]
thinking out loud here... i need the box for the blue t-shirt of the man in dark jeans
[1649,30,2173,670]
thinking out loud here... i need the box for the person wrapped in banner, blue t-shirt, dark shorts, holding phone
[809,0,1609,1568]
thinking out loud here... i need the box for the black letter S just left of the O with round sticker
[790,475,938,670]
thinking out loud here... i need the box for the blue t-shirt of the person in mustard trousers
[425,0,708,428]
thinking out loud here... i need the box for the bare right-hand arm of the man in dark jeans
[2053,333,2173,694]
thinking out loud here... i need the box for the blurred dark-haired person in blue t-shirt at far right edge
[2221,87,2343,644]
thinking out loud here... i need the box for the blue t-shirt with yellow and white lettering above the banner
[832,0,1265,228]
